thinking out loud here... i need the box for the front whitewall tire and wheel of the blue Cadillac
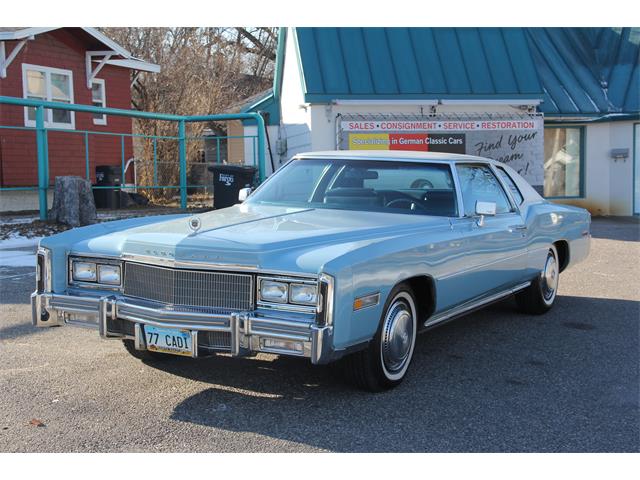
[343,283,418,392]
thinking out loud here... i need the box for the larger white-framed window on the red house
[22,63,75,129]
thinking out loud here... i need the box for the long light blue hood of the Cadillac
[62,204,449,272]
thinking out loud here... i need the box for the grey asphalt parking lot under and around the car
[0,219,640,452]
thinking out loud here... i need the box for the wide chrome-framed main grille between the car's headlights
[124,262,253,310]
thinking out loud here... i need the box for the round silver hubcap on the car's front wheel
[382,300,414,374]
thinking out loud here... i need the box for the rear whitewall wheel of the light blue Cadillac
[516,245,560,315]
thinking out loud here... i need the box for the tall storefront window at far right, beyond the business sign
[544,127,582,197]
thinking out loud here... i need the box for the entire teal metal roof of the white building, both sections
[248,27,640,119]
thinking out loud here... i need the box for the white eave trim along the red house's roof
[0,27,160,73]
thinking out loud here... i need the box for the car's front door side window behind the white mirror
[456,165,511,216]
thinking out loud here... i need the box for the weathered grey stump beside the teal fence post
[50,177,97,227]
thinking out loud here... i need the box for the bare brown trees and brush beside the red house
[103,27,277,201]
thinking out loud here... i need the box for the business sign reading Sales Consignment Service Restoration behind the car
[338,114,544,188]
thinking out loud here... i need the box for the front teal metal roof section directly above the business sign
[296,28,543,101]
